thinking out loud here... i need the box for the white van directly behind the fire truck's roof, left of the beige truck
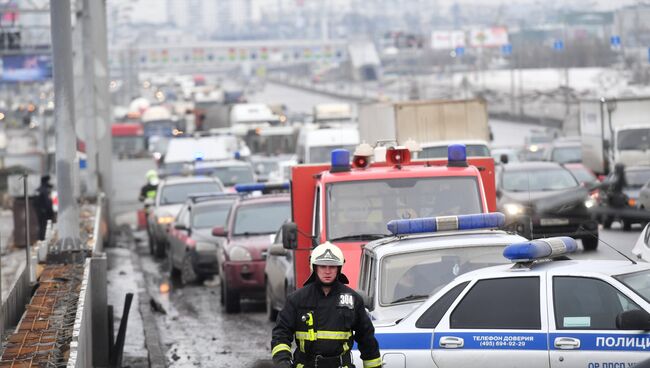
[296,125,359,163]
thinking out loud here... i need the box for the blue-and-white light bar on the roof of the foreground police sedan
[503,236,578,262]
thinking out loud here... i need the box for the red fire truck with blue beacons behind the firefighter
[282,142,496,287]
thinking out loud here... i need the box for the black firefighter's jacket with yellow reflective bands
[271,281,381,368]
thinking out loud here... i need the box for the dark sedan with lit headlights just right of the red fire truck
[497,162,598,250]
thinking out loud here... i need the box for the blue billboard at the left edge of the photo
[2,55,52,82]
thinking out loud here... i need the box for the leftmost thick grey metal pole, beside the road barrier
[50,0,81,251]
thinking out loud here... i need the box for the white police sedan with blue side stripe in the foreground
[355,237,650,368]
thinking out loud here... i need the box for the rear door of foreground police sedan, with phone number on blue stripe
[431,274,549,368]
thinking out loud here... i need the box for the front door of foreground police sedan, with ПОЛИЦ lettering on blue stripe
[547,274,650,368]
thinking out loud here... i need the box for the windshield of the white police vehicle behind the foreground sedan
[379,245,506,305]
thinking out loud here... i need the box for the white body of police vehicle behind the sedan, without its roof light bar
[358,229,526,321]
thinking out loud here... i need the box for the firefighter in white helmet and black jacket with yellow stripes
[271,242,382,368]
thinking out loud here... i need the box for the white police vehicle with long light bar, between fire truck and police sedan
[358,213,527,320]
